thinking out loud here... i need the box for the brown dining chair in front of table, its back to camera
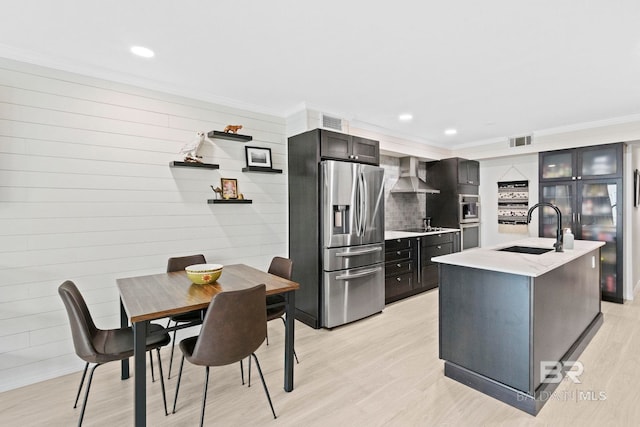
[173,285,276,426]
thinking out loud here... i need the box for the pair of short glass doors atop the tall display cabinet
[539,143,622,181]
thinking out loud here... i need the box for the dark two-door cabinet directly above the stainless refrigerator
[320,129,380,165]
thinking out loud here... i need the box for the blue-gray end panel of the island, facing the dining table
[439,264,533,394]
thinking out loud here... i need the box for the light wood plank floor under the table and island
[0,290,640,427]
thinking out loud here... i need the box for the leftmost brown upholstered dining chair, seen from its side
[58,280,171,426]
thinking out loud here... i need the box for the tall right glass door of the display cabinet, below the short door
[576,179,623,302]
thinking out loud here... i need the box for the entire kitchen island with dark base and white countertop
[432,238,604,415]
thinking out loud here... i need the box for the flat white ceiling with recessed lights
[0,0,640,146]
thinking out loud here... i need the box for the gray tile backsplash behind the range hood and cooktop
[380,156,426,230]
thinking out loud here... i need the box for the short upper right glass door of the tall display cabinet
[577,144,622,179]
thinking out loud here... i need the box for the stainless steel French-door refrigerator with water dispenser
[320,160,384,328]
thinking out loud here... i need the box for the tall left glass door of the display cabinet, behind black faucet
[537,181,580,239]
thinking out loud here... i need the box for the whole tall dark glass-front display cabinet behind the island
[539,143,624,303]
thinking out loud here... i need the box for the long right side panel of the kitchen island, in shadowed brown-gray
[533,249,601,390]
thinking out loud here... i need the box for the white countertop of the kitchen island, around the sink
[431,237,605,277]
